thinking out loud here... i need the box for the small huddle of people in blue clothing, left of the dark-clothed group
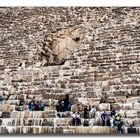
[28,100,45,111]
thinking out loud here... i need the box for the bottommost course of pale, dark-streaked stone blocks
[0,126,137,134]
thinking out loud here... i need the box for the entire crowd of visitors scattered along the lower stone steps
[0,95,136,134]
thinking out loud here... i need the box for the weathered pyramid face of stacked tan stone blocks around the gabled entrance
[0,7,140,134]
